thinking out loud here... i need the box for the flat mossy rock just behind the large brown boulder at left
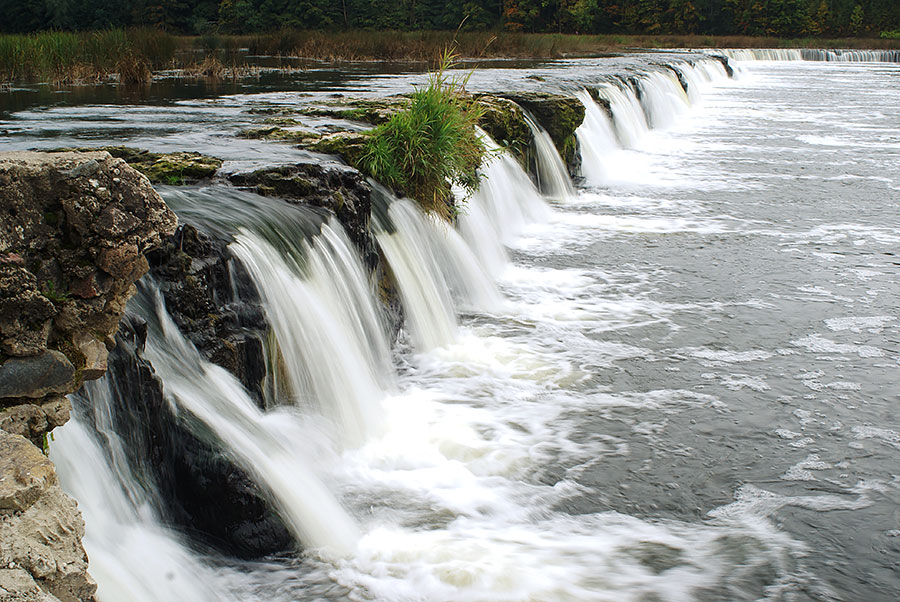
[54,146,222,184]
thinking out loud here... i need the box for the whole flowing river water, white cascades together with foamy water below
[2,54,900,602]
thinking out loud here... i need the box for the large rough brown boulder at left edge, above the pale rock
[0,152,177,444]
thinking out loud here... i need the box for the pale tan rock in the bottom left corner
[0,431,97,602]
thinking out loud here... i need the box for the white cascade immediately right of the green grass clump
[458,130,551,276]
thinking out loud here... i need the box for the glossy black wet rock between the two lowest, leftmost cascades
[92,317,295,558]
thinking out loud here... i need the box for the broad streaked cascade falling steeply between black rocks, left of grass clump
[230,221,392,446]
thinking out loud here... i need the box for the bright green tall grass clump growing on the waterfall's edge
[358,50,485,219]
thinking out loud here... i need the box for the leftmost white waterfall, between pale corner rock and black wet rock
[50,377,237,602]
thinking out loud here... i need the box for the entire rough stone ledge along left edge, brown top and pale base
[0,152,177,601]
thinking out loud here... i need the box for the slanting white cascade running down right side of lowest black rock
[142,280,359,555]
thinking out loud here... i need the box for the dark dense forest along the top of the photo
[0,0,900,37]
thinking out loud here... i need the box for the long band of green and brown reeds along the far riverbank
[0,28,900,84]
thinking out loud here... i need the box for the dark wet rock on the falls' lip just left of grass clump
[228,163,378,269]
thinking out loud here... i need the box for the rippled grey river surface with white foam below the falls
[10,55,900,601]
